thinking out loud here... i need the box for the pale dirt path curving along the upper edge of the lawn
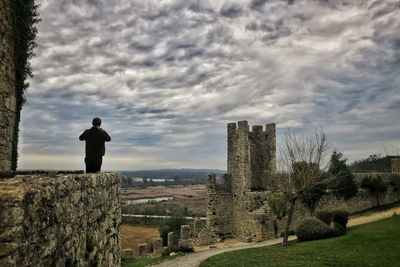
[152,207,400,267]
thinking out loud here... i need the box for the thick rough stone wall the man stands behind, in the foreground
[0,173,121,267]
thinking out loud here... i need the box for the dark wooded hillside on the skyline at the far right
[350,154,398,173]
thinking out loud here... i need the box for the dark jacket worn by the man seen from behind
[79,127,111,158]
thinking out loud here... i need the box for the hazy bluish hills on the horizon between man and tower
[121,169,226,180]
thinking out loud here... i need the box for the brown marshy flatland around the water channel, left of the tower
[122,185,206,216]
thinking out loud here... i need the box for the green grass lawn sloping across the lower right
[200,216,400,267]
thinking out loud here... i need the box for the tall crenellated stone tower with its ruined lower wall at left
[207,121,276,240]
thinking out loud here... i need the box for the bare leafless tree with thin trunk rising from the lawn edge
[279,129,330,246]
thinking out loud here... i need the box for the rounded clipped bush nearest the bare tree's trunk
[296,217,331,241]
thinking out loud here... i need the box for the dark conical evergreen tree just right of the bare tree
[328,151,358,200]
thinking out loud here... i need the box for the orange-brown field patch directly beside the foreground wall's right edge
[121,224,160,254]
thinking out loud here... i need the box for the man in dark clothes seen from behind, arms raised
[79,117,111,173]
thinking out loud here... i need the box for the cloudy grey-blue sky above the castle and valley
[18,0,400,170]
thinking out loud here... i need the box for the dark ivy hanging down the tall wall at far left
[10,0,40,170]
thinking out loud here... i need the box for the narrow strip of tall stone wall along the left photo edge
[0,0,16,172]
